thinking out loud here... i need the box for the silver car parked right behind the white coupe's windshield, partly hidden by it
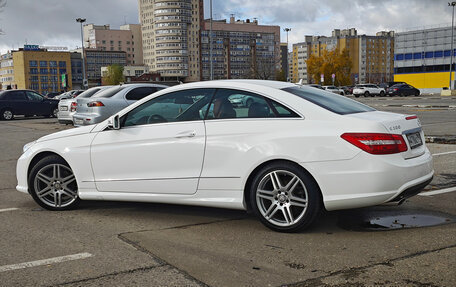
[73,84,167,126]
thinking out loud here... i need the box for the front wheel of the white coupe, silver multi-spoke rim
[28,155,80,211]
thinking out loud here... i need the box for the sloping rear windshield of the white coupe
[282,87,375,115]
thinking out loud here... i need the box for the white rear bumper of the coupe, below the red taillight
[303,148,434,210]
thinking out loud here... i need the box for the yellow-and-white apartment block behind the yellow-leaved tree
[293,28,394,84]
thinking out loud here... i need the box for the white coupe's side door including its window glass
[91,89,214,194]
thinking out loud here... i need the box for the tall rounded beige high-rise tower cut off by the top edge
[138,0,204,81]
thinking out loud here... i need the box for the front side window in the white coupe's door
[121,89,215,127]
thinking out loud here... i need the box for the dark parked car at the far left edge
[0,90,59,120]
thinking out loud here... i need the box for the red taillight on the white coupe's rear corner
[340,133,407,154]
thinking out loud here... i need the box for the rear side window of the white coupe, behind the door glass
[207,89,275,120]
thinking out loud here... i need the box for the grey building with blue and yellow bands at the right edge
[394,27,456,92]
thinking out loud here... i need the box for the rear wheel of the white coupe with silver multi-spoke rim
[250,162,322,232]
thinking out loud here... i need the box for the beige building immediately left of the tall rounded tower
[83,24,143,65]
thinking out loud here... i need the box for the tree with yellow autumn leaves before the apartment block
[307,49,352,86]
